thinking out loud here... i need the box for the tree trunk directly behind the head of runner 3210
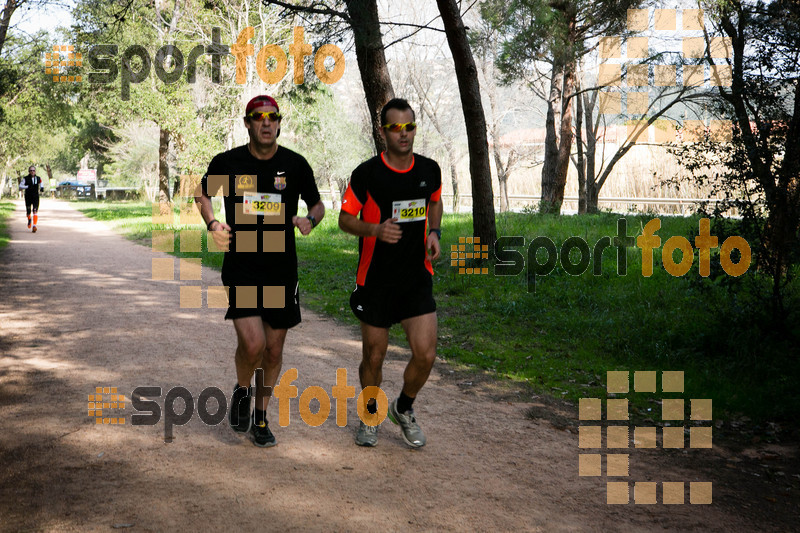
[345,0,394,153]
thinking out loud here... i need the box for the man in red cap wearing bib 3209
[195,95,325,447]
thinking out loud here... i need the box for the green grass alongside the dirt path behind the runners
[78,202,800,422]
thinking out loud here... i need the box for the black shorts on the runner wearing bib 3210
[350,276,436,328]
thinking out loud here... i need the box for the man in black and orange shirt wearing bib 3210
[339,98,442,447]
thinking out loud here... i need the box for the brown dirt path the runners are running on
[0,200,797,531]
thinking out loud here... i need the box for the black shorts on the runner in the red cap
[223,279,300,329]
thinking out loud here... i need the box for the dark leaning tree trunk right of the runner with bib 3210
[436,0,497,245]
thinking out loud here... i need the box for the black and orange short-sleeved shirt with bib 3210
[342,154,442,287]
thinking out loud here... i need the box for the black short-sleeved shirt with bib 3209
[201,145,320,285]
